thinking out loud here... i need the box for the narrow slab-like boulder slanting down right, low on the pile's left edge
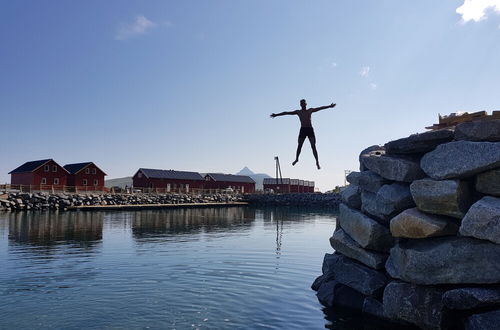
[330,229,389,269]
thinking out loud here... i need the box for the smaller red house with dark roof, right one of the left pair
[64,162,107,190]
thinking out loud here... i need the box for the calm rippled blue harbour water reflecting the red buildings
[0,207,372,329]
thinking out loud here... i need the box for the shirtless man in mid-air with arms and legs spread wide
[271,99,336,170]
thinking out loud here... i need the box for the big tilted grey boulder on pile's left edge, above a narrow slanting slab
[337,204,394,252]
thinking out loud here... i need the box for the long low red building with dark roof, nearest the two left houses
[132,168,205,192]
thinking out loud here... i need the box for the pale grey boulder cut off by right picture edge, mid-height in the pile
[460,196,500,244]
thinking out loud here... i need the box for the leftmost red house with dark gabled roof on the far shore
[9,159,68,186]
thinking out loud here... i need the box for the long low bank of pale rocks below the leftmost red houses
[0,192,241,211]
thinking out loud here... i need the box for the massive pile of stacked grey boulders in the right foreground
[312,120,500,329]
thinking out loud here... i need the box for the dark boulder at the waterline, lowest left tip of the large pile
[316,281,365,310]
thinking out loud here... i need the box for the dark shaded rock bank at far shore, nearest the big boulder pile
[244,193,341,208]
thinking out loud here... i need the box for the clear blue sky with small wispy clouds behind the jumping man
[0,0,500,191]
